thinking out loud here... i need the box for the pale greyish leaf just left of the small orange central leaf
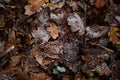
[32,28,50,41]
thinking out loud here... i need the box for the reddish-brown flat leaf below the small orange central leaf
[40,42,63,59]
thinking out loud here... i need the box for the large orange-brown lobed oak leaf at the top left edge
[25,0,48,15]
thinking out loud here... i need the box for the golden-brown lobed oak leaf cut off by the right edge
[108,26,120,44]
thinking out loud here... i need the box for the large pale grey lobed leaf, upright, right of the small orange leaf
[67,13,85,35]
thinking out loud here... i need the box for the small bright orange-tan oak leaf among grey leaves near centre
[48,23,59,39]
